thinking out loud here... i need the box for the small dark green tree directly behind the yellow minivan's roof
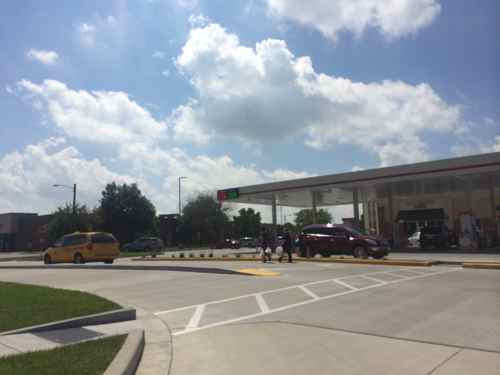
[48,204,92,242]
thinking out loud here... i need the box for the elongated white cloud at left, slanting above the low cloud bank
[17,80,166,144]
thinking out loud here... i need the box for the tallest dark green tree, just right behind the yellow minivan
[98,182,157,243]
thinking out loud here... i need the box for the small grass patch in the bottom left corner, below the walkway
[0,335,126,375]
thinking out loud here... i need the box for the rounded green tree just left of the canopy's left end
[179,193,229,245]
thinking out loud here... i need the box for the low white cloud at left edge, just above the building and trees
[0,138,137,213]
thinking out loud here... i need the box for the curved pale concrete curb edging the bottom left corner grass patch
[103,330,145,375]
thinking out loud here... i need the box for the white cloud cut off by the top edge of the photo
[266,0,441,41]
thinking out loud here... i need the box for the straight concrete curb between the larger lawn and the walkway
[0,309,136,336]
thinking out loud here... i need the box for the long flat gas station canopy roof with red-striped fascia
[218,152,500,208]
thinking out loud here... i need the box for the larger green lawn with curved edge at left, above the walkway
[0,282,121,334]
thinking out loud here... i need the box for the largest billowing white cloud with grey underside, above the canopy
[173,24,461,165]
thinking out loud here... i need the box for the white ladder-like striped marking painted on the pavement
[155,268,461,336]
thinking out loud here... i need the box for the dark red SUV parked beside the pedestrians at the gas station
[299,224,390,259]
